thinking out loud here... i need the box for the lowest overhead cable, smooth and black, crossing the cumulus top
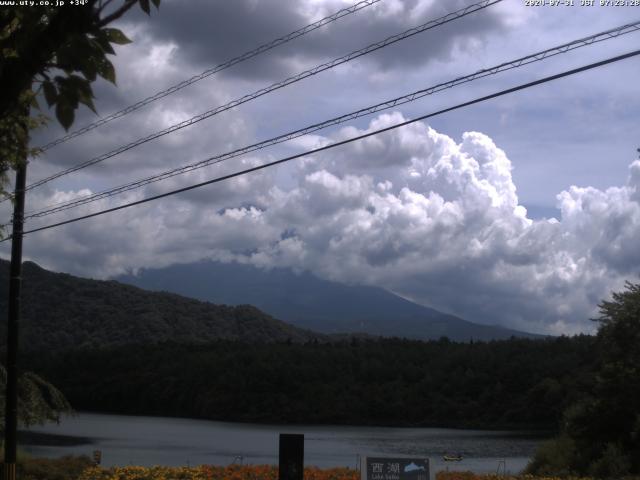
[7,50,640,242]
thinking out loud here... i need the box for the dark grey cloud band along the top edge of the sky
[138,0,504,79]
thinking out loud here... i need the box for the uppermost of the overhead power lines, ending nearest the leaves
[38,0,380,152]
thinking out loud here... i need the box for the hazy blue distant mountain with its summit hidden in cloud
[117,261,539,342]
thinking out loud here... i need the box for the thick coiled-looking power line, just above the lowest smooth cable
[25,21,640,219]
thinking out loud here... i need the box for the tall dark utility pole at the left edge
[3,155,27,480]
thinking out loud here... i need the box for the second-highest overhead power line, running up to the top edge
[17,0,503,197]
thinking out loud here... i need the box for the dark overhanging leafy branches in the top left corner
[0,0,160,193]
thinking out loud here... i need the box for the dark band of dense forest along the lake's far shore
[23,336,595,429]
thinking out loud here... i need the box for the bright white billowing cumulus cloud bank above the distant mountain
[8,113,640,333]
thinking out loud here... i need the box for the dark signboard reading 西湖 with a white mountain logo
[360,457,429,480]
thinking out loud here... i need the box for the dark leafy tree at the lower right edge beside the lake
[529,282,640,477]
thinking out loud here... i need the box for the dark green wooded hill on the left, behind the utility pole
[0,260,322,351]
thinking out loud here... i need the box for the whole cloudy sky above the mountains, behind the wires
[0,0,640,335]
